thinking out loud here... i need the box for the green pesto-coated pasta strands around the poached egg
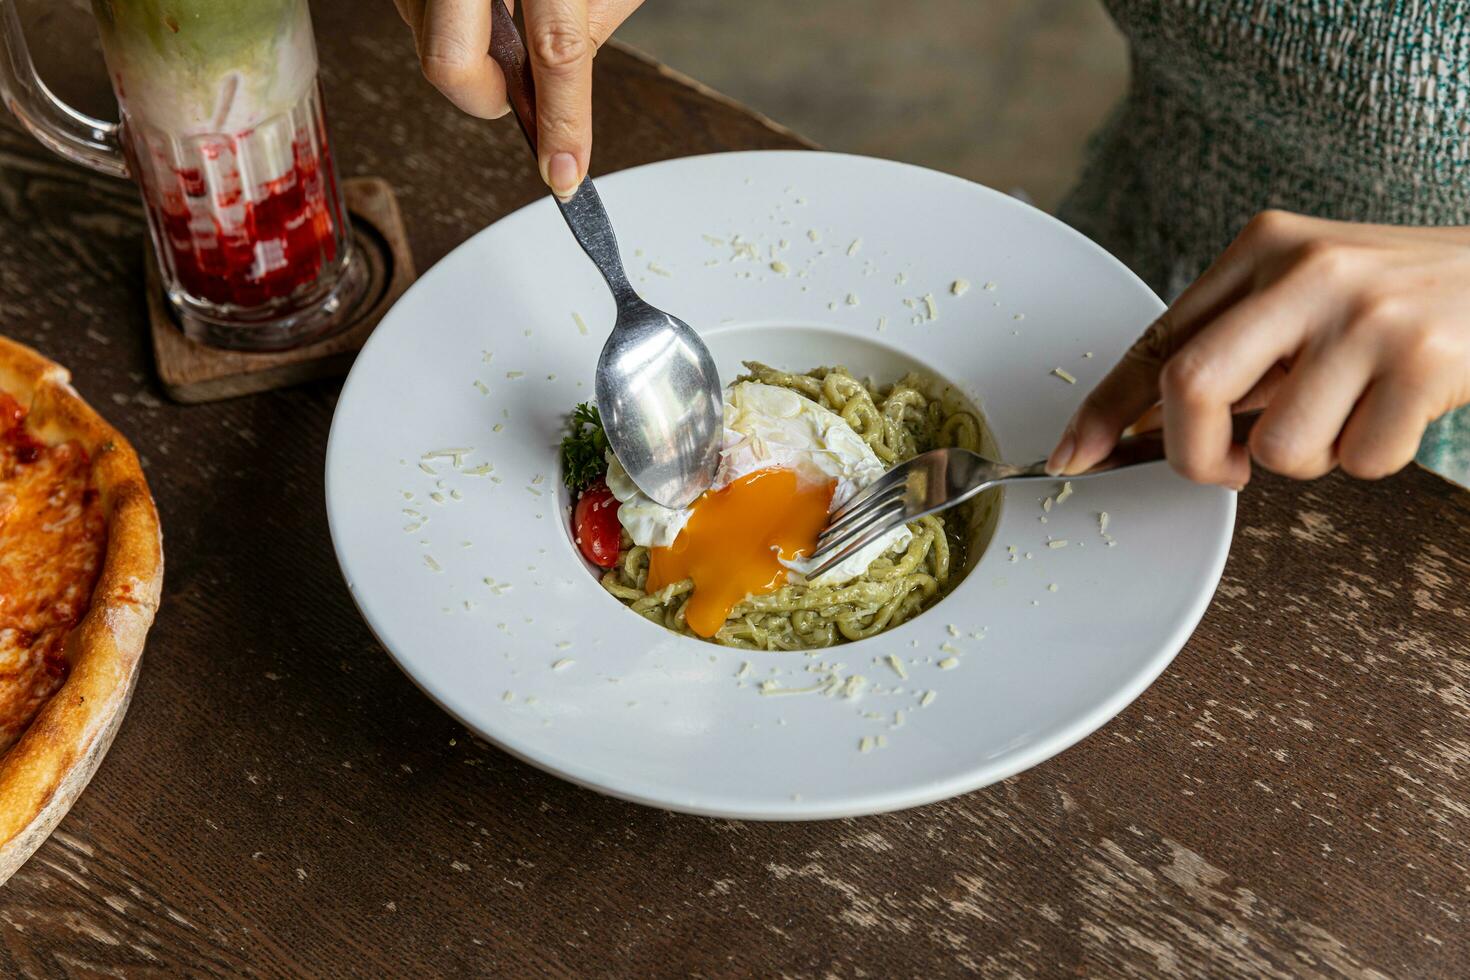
[603,361,989,649]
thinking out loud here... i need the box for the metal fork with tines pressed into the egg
[807,411,1260,579]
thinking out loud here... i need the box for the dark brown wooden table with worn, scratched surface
[0,0,1470,977]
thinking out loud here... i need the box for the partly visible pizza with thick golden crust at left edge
[0,336,163,883]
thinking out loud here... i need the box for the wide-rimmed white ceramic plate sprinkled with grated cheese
[326,153,1235,820]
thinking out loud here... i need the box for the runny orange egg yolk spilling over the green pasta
[648,469,836,636]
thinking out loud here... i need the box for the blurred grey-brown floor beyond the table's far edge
[617,0,1127,210]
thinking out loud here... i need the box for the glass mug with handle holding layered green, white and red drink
[0,0,368,350]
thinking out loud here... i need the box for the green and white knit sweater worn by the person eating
[1061,0,1470,483]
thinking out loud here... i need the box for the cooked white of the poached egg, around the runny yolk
[607,381,913,585]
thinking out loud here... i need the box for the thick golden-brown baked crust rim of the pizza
[0,336,163,883]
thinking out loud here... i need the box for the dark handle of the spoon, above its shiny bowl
[490,0,638,307]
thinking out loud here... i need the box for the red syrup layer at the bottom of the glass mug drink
[154,132,338,307]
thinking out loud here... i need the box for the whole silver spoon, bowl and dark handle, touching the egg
[490,0,723,508]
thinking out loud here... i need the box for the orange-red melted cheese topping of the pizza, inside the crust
[0,392,106,752]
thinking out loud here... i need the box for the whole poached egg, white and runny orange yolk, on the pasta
[607,381,913,636]
